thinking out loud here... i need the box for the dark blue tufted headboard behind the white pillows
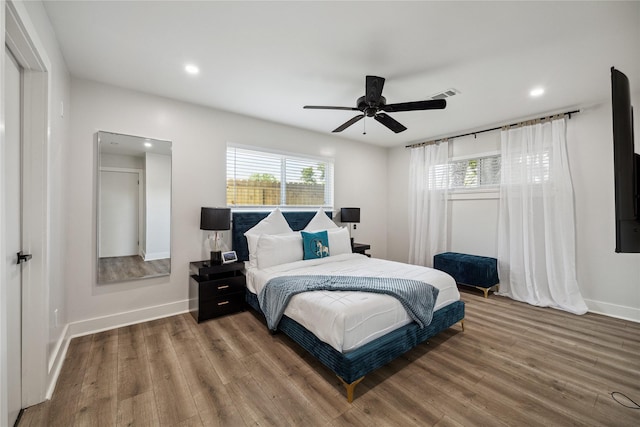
[231,211,332,261]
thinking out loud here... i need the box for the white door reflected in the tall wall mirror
[98,170,139,258]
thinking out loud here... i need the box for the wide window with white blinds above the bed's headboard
[227,145,333,208]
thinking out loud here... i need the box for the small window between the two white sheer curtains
[449,154,501,189]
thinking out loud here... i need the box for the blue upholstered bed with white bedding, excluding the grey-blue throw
[232,211,464,402]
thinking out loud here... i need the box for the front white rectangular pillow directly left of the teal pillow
[255,232,303,269]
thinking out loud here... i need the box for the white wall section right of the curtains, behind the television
[567,92,640,321]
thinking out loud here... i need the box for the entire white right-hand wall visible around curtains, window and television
[388,98,640,321]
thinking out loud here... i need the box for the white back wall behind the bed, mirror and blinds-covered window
[65,79,387,333]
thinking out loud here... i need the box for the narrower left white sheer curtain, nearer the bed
[409,141,449,267]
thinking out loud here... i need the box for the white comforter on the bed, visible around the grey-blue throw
[246,254,460,352]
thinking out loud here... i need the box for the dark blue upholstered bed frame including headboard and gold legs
[232,212,464,402]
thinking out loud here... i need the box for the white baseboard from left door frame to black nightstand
[45,300,189,399]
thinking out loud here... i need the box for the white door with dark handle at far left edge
[5,47,22,426]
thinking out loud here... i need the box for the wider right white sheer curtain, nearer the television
[498,118,587,314]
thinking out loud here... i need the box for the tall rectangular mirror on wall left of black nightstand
[96,131,171,283]
